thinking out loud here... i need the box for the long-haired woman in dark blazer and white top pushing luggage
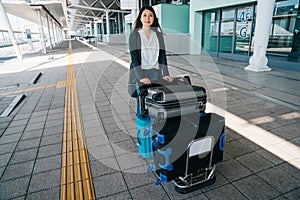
[128,6,173,97]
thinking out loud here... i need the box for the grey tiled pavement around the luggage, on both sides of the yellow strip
[0,41,300,199]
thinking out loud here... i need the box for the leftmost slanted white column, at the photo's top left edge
[0,1,23,60]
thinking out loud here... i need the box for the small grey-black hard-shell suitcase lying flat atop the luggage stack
[145,84,207,119]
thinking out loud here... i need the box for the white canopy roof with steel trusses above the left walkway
[2,0,130,31]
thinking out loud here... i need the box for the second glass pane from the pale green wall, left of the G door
[219,9,235,53]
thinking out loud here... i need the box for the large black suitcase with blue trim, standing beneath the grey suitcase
[152,113,225,182]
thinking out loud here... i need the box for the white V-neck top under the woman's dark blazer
[139,29,159,69]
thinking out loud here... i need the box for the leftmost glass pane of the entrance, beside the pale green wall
[202,11,219,51]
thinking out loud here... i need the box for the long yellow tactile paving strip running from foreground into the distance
[60,42,95,200]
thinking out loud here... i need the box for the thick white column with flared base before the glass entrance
[245,0,275,72]
